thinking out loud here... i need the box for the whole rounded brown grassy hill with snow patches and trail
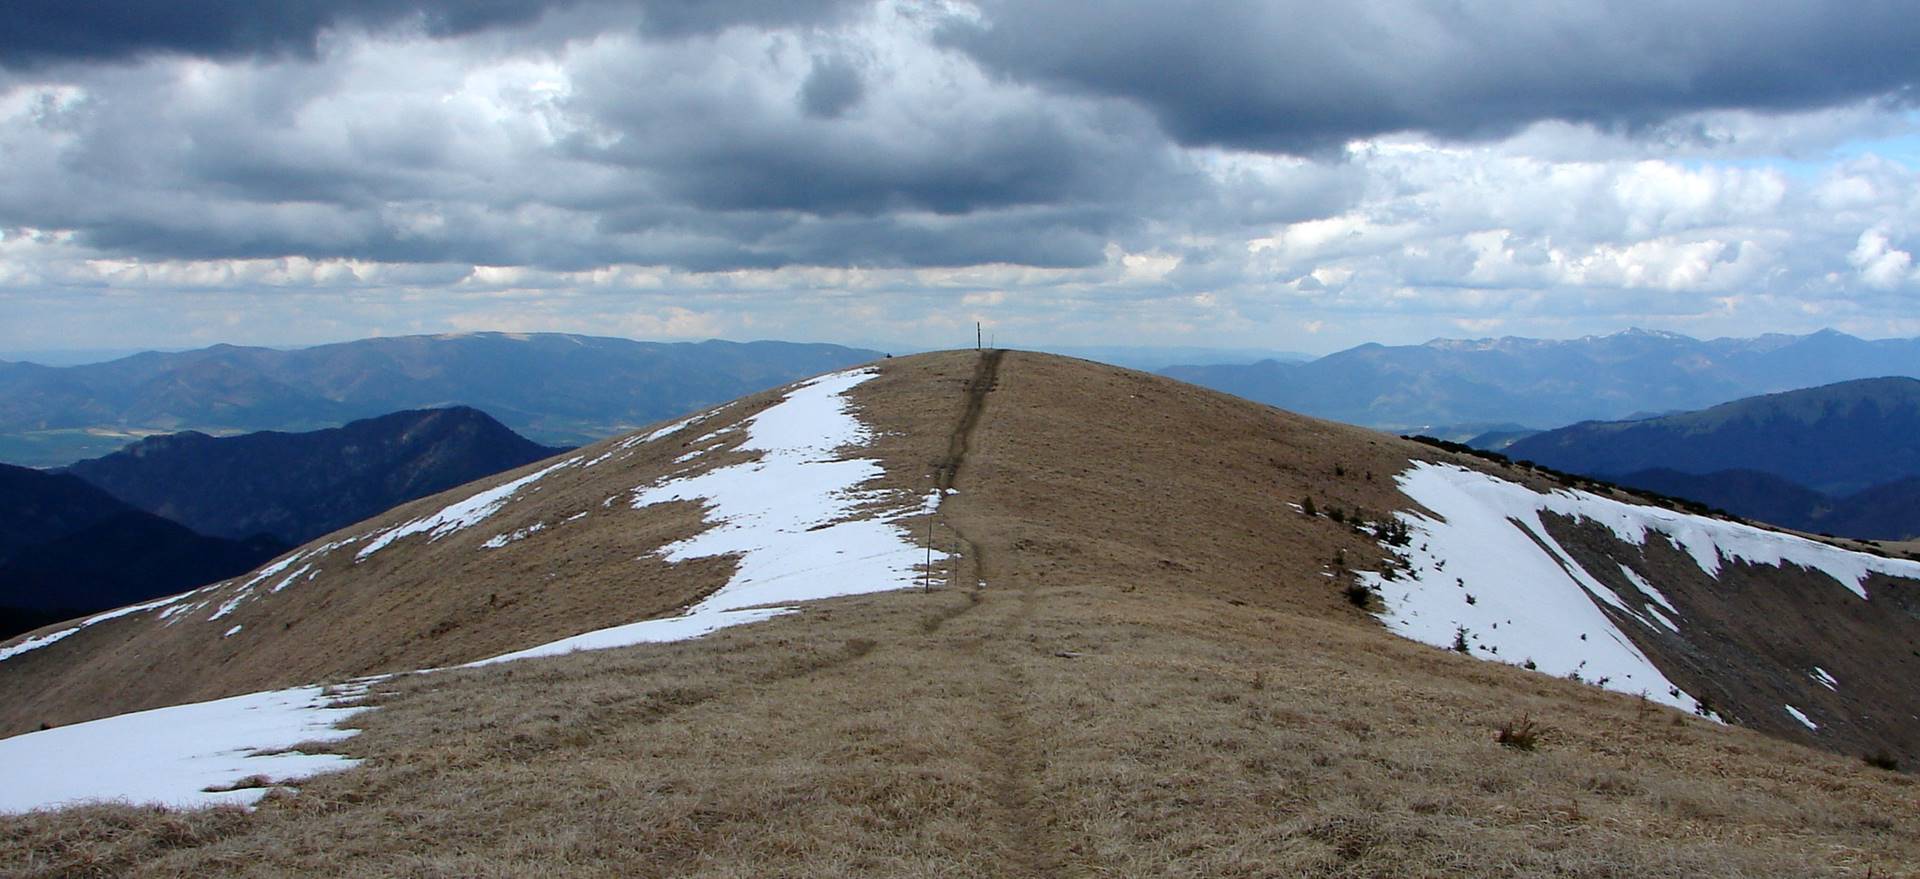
[0,351,1920,877]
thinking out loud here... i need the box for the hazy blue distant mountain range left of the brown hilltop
[0,332,879,466]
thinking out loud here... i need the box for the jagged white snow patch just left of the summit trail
[476,368,945,664]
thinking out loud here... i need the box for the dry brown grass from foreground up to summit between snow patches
[0,355,1920,877]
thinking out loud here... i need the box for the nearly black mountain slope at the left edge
[0,464,288,637]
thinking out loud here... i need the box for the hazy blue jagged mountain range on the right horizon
[1162,330,1920,432]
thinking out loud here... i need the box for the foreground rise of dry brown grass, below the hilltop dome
[0,585,1920,877]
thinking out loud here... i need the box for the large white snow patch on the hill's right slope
[1363,463,1920,708]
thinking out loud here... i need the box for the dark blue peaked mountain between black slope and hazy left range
[67,407,564,545]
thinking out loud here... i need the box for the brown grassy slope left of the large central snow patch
[0,378,814,735]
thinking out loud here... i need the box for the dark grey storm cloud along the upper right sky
[943,0,1920,152]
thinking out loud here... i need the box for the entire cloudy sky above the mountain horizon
[0,0,1920,351]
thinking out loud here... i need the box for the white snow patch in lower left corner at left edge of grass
[0,683,365,812]
